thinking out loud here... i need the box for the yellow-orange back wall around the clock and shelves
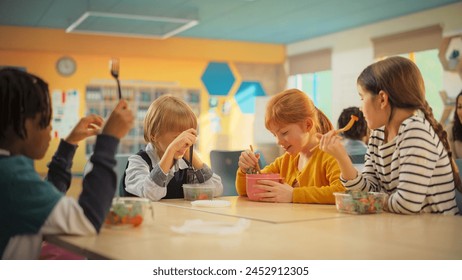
[0,26,285,173]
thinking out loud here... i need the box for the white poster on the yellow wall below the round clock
[52,89,80,139]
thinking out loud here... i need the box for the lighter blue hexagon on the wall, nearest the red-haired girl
[234,81,266,114]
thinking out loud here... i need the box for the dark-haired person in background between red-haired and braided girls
[337,107,367,156]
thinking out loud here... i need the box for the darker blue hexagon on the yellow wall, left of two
[201,62,235,96]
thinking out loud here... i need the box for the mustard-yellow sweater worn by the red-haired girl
[236,149,346,204]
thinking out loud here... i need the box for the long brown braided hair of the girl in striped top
[357,56,462,190]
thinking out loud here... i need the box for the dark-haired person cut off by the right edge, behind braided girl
[446,91,462,159]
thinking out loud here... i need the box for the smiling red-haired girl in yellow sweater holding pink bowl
[236,89,345,204]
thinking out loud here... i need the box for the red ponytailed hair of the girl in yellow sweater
[265,89,334,134]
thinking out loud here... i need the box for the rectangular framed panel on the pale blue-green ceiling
[66,12,199,39]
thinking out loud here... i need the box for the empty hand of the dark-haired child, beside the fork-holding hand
[64,115,104,145]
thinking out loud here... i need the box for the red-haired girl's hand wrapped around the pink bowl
[254,180,294,202]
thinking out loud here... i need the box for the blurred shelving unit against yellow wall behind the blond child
[85,84,200,157]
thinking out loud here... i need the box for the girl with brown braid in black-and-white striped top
[319,57,460,215]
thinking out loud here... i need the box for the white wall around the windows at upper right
[287,3,462,120]
